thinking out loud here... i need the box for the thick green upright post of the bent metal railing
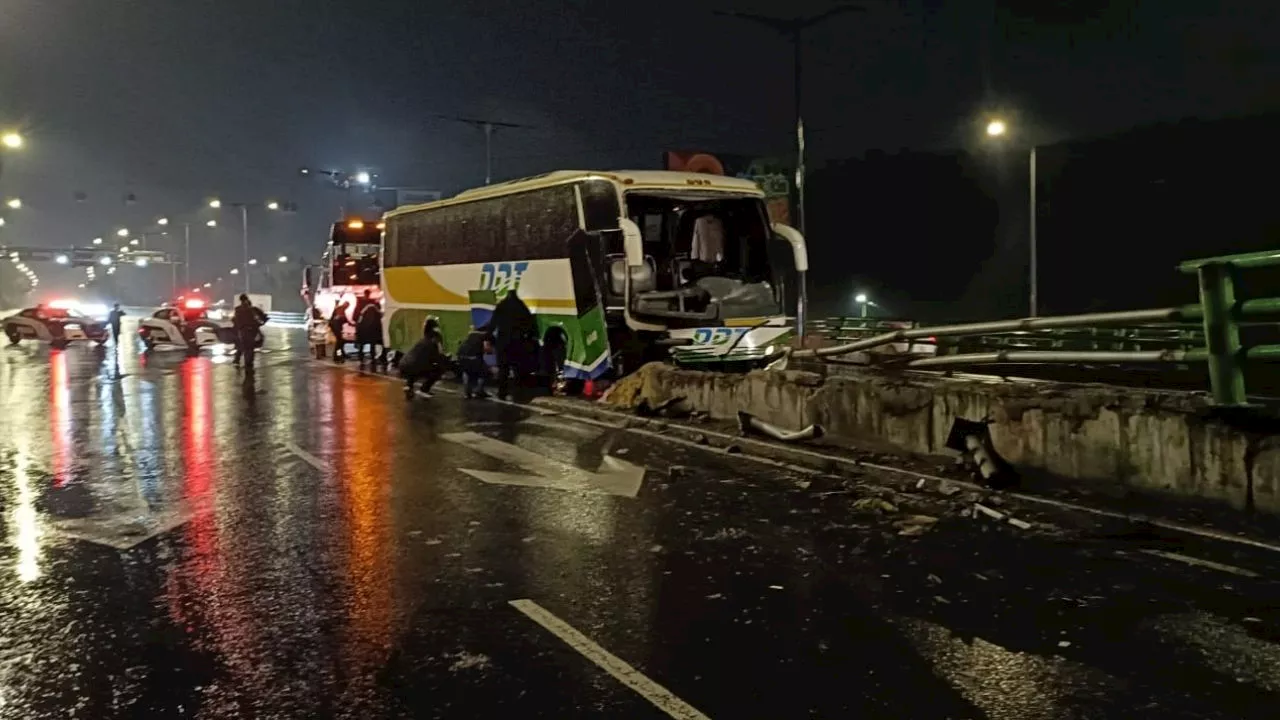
[1197,263,1245,405]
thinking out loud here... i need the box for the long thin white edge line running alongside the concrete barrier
[540,397,1280,552]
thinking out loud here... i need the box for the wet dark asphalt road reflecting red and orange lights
[0,322,1280,720]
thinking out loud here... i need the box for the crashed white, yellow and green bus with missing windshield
[381,170,808,380]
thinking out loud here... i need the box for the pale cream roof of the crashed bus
[385,170,764,218]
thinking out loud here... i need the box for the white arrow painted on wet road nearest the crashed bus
[440,433,645,497]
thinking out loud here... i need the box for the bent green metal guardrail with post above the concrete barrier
[787,245,1280,406]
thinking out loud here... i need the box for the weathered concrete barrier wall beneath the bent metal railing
[618,364,1280,514]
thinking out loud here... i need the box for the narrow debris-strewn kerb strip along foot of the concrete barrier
[530,397,1280,552]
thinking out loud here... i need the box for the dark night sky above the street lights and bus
[0,0,1280,292]
